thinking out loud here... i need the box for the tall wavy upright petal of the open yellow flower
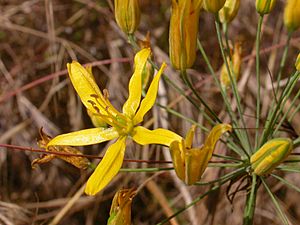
[123,48,151,118]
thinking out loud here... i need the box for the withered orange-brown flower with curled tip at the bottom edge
[107,188,136,225]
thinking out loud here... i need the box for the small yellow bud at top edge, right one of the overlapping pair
[219,0,240,23]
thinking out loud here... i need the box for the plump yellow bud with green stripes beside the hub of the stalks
[250,138,293,176]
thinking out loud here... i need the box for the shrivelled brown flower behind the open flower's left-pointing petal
[31,128,90,170]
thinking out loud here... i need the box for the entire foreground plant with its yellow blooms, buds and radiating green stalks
[32,0,300,225]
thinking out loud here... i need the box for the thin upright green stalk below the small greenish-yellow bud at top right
[254,15,264,151]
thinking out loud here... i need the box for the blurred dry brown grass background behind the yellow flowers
[0,0,300,225]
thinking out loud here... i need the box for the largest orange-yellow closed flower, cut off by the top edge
[169,0,202,70]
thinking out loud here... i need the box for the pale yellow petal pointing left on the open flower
[47,127,119,147]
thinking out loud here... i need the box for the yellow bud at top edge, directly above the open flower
[115,0,141,34]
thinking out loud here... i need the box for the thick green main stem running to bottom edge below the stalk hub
[243,174,257,225]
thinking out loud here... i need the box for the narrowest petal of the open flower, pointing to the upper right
[133,63,166,124]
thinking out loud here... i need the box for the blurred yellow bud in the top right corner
[283,0,300,31]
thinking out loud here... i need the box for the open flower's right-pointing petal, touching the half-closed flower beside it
[132,126,182,147]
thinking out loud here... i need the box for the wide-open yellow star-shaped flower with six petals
[47,48,181,195]
